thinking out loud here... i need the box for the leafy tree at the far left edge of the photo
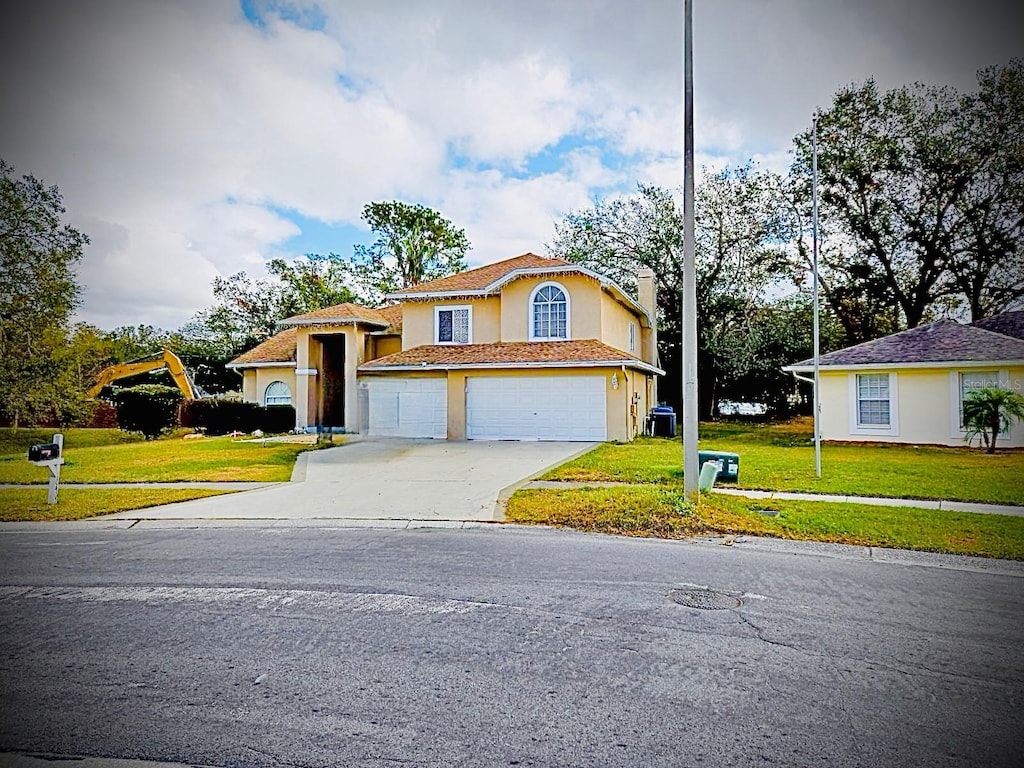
[0,160,89,426]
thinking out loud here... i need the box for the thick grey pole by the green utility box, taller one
[682,0,700,499]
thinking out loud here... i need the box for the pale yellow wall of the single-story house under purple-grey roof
[820,364,1024,447]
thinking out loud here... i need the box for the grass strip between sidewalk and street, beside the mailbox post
[0,487,229,522]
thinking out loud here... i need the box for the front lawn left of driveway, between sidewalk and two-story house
[0,430,319,483]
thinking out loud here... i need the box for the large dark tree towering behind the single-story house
[791,59,1024,343]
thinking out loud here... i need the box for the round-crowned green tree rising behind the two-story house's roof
[352,201,470,303]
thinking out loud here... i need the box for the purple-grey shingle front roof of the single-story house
[783,321,1024,371]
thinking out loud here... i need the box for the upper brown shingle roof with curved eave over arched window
[389,253,653,327]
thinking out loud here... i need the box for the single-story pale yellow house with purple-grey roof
[783,311,1024,447]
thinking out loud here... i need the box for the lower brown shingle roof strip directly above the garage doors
[359,339,665,375]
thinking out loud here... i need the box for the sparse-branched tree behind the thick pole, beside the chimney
[548,164,792,418]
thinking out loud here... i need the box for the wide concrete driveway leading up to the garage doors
[101,437,593,520]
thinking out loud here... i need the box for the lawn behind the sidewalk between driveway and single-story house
[544,420,1024,505]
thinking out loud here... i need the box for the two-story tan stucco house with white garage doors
[229,254,664,440]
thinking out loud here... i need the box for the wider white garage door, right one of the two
[466,376,607,440]
